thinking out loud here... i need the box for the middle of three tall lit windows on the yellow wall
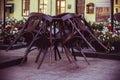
[38,0,48,14]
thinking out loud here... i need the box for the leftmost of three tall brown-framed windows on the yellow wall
[22,0,30,16]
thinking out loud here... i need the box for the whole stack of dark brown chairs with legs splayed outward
[7,13,108,69]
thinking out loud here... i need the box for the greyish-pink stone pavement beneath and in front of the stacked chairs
[0,49,120,80]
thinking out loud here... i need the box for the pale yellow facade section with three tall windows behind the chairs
[6,0,76,19]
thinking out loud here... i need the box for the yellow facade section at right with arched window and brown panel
[84,0,120,22]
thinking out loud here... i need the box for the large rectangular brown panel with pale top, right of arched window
[96,0,111,22]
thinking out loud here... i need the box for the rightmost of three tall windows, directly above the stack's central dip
[56,0,66,14]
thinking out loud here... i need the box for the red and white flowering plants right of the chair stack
[95,25,120,52]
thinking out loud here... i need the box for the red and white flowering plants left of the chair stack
[0,18,25,45]
